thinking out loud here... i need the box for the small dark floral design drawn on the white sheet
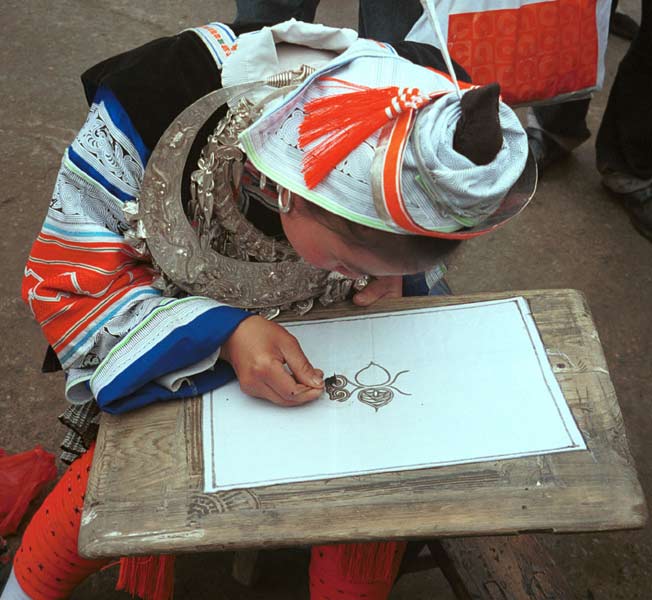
[325,361,412,412]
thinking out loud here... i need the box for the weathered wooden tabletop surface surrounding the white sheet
[79,290,647,557]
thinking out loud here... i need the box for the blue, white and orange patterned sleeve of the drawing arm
[22,88,249,412]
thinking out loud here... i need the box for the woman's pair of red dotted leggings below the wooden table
[14,446,405,600]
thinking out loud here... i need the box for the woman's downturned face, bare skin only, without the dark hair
[281,196,432,278]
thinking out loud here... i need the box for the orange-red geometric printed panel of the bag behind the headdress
[447,0,598,105]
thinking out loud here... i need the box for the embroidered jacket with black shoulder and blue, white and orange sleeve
[22,18,466,460]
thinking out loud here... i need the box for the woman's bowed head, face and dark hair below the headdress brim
[281,195,459,277]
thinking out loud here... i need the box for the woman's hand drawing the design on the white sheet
[220,316,324,406]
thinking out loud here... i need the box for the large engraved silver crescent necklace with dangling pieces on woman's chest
[130,65,366,318]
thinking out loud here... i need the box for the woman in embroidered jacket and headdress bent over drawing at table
[2,21,529,600]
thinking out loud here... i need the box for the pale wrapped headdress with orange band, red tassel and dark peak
[239,48,534,244]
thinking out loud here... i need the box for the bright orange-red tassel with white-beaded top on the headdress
[299,86,430,189]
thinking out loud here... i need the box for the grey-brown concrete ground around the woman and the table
[0,0,652,600]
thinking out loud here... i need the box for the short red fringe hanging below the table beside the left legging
[115,555,175,600]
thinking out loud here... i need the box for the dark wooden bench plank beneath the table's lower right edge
[428,535,575,600]
